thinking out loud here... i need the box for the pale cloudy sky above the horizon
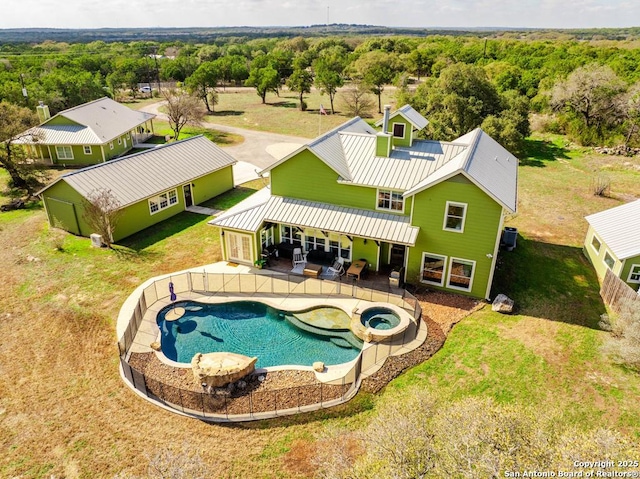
[0,0,640,28]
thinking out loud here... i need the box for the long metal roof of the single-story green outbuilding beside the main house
[39,136,236,207]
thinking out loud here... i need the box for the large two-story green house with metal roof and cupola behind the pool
[211,105,518,298]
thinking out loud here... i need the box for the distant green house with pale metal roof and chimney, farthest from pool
[18,97,155,166]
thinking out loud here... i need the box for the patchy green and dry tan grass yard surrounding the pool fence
[0,123,640,478]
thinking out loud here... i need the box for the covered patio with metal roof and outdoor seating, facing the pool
[210,188,419,287]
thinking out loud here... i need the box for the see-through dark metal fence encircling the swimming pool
[118,272,422,420]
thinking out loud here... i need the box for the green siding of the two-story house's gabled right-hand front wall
[406,175,502,298]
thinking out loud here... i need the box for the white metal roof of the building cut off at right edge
[585,200,640,260]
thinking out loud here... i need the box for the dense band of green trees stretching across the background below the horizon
[0,34,640,195]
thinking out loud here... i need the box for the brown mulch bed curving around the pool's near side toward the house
[129,291,484,414]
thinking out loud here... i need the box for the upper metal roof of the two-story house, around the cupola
[263,115,518,212]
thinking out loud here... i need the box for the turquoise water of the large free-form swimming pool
[157,301,362,368]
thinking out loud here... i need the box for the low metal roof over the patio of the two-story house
[209,193,419,246]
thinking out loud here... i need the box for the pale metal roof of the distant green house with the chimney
[22,97,155,145]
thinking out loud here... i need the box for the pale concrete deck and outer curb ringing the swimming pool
[116,262,427,422]
